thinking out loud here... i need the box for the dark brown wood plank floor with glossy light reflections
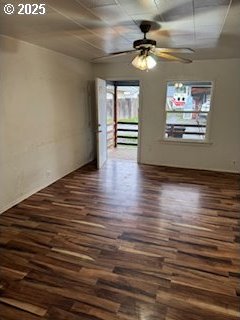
[0,160,240,320]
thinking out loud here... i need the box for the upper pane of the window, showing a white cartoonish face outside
[166,81,212,112]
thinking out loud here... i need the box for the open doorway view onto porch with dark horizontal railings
[106,80,139,162]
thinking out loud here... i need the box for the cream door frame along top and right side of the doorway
[104,77,143,163]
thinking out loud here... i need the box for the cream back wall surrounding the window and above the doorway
[94,59,240,172]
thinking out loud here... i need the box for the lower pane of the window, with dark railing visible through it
[165,112,207,140]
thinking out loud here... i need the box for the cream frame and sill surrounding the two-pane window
[160,79,215,145]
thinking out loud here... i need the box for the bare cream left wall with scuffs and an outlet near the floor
[0,36,93,212]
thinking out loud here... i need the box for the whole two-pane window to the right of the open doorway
[164,81,212,141]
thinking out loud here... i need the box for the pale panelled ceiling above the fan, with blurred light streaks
[0,0,240,62]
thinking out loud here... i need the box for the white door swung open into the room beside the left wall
[96,78,107,169]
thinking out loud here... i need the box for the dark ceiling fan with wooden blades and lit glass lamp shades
[94,21,194,70]
